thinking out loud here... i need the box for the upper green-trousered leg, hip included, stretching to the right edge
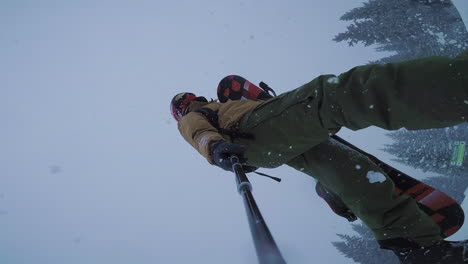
[234,53,468,168]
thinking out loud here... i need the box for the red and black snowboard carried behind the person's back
[217,75,465,238]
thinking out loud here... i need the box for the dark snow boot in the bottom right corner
[394,240,468,264]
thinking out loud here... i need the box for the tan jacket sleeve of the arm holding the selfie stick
[177,112,225,164]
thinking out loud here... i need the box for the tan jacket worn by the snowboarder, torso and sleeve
[177,100,262,164]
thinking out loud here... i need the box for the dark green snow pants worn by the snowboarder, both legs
[233,52,468,249]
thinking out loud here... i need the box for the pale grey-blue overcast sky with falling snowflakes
[0,0,464,264]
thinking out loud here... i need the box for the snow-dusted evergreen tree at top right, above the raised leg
[334,0,468,63]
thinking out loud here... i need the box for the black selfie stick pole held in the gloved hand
[231,156,286,264]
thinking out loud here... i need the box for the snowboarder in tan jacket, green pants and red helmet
[171,51,468,264]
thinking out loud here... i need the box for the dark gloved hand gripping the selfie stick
[210,141,252,172]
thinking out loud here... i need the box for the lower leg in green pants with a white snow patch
[287,140,442,248]
